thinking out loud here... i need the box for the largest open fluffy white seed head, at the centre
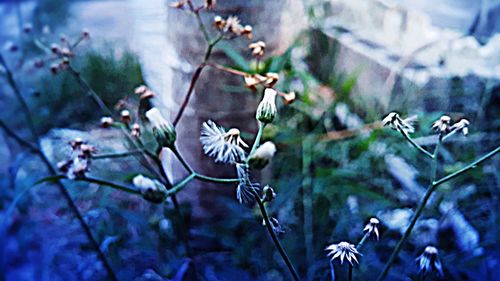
[200,120,248,163]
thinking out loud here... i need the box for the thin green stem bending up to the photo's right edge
[377,146,500,281]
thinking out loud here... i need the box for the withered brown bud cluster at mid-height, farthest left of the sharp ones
[57,138,96,179]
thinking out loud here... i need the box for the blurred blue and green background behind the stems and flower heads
[0,0,500,281]
